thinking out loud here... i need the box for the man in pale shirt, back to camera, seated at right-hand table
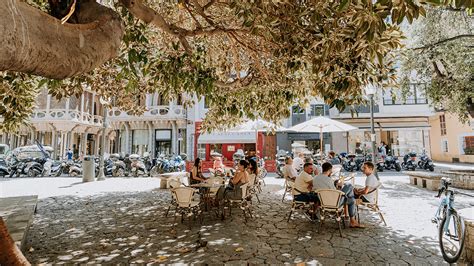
[313,163,361,228]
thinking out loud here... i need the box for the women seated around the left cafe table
[190,158,258,202]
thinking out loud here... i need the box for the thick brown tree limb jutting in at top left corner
[0,0,123,79]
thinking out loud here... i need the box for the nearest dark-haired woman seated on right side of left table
[216,160,250,201]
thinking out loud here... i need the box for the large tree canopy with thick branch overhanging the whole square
[0,0,473,130]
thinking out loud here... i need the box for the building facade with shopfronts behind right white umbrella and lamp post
[277,84,433,156]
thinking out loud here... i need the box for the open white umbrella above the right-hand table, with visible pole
[287,116,357,158]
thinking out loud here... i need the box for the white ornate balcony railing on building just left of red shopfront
[109,105,186,120]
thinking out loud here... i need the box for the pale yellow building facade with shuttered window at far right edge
[430,112,474,163]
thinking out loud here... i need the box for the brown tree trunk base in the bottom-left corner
[0,217,30,265]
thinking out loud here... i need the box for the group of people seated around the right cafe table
[283,157,380,228]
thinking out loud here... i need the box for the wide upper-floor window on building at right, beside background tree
[383,83,428,105]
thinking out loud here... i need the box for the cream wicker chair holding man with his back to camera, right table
[316,189,346,237]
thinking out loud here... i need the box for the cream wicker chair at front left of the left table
[171,187,202,227]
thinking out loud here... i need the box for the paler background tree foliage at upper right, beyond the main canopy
[402,8,474,121]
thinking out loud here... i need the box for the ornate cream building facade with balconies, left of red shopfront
[0,89,187,159]
